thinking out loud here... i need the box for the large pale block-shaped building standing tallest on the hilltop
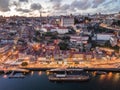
[60,17,74,27]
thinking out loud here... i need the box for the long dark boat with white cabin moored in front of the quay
[48,69,90,81]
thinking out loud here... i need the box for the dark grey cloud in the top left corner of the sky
[0,0,10,12]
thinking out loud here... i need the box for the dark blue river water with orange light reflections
[0,71,120,90]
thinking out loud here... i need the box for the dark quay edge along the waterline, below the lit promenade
[0,67,120,73]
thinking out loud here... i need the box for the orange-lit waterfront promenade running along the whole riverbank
[0,59,120,72]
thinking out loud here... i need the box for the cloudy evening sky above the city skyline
[0,0,120,17]
